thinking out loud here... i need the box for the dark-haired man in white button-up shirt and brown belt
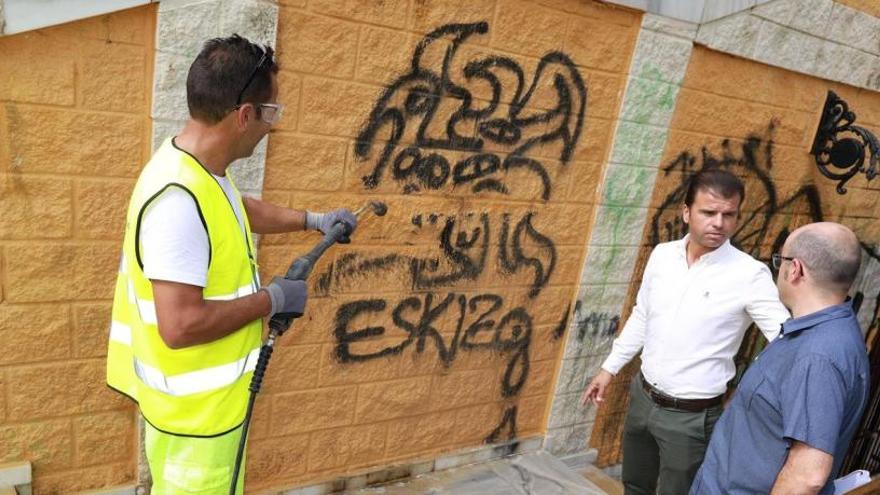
[582,168,789,495]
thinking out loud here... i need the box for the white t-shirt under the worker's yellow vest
[140,174,245,287]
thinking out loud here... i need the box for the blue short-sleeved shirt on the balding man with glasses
[691,302,870,495]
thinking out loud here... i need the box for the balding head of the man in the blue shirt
[785,222,862,294]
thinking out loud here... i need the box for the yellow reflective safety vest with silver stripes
[107,139,262,436]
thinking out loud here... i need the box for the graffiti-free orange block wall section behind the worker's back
[0,6,155,494]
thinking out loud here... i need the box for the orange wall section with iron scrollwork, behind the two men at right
[592,46,880,464]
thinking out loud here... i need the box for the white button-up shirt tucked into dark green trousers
[602,236,790,399]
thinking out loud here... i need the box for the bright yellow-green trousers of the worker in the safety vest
[144,421,244,495]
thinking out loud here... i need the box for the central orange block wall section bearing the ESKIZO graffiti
[248,0,640,489]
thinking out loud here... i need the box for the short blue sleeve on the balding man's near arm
[780,354,846,455]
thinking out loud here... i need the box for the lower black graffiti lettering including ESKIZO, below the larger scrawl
[324,212,557,443]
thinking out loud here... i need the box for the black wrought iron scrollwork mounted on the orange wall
[810,91,880,194]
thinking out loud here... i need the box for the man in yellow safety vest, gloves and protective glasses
[107,35,357,494]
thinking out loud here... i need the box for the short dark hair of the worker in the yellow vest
[186,34,278,124]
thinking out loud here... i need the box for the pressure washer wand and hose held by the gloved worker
[229,201,388,495]
